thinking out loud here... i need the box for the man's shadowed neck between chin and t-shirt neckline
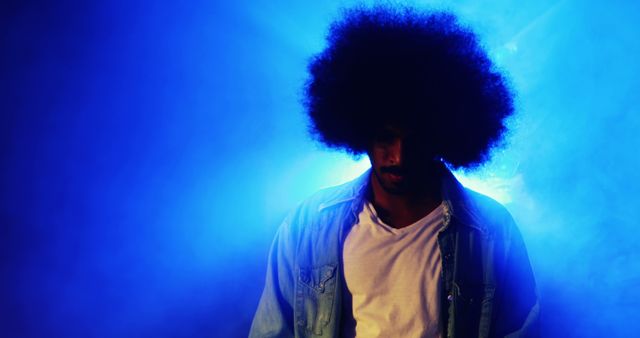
[369,174,442,229]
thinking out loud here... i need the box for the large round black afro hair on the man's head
[303,6,514,169]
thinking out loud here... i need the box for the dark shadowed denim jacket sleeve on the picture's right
[491,217,540,338]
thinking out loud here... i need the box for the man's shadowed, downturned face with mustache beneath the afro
[368,127,437,195]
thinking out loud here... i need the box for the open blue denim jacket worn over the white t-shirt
[249,169,539,338]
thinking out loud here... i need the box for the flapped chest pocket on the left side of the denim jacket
[294,265,336,335]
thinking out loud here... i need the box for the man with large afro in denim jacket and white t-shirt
[250,7,538,338]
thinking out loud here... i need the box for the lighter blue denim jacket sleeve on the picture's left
[249,220,294,338]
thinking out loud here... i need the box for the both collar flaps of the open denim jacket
[318,164,486,232]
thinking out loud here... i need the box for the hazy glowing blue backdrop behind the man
[0,0,640,337]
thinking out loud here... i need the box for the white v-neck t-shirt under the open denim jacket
[343,202,444,338]
